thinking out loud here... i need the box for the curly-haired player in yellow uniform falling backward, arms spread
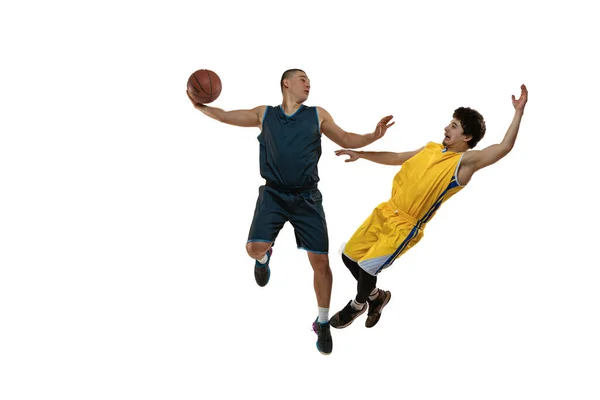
[329,85,528,328]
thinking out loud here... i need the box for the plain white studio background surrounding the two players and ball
[0,0,600,400]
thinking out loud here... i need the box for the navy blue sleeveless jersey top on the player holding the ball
[258,105,321,189]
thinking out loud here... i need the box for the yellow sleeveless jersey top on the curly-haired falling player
[389,142,464,228]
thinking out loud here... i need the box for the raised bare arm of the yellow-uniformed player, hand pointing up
[463,85,528,174]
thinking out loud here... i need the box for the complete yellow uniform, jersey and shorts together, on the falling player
[344,142,464,276]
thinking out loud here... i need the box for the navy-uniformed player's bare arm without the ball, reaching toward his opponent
[318,107,395,149]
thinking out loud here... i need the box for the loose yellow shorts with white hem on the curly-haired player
[343,202,423,276]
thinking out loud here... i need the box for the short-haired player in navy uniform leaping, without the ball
[188,69,394,354]
